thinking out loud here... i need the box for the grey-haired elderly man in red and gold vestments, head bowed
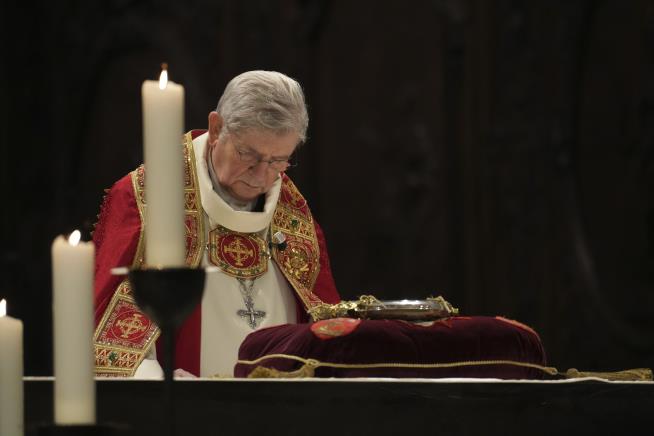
[94,71,346,377]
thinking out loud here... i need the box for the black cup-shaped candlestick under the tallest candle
[128,267,205,435]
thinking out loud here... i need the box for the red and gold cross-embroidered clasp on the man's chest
[209,225,268,279]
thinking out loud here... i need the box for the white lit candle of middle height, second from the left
[52,230,95,425]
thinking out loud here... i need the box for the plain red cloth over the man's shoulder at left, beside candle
[93,174,141,327]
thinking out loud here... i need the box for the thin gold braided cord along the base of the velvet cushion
[237,354,559,375]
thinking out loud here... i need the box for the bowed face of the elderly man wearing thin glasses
[207,112,299,202]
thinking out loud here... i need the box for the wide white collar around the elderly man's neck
[193,133,282,233]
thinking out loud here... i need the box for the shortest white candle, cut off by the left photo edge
[0,300,24,436]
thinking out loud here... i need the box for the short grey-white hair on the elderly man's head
[216,70,309,143]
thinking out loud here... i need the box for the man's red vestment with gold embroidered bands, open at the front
[93,130,340,376]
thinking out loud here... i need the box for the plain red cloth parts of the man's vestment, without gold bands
[93,137,340,375]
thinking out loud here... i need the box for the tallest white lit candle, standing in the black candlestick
[141,66,186,267]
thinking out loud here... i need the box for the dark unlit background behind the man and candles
[0,0,654,375]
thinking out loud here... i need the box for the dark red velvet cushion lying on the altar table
[234,317,546,379]
